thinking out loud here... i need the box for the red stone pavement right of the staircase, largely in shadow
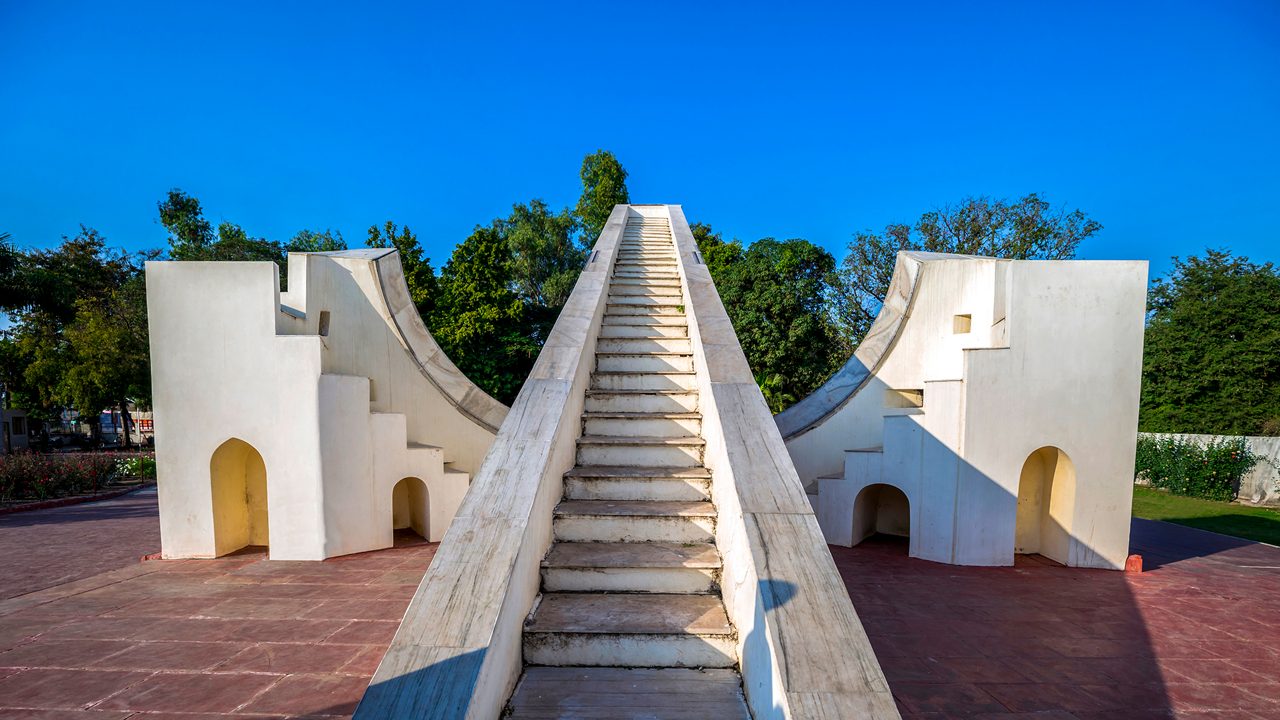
[831,520,1280,720]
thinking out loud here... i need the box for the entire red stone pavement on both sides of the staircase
[0,484,1280,720]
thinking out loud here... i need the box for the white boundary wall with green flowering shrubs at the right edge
[1134,433,1280,505]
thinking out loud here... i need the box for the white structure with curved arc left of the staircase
[146,250,507,560]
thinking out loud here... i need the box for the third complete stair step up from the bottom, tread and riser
[552,500,716,542]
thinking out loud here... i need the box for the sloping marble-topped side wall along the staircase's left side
[356,205,627,720]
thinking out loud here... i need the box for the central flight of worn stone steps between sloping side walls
[506,218,750,720]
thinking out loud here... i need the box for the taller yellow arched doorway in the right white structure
[1014,446,1075,565]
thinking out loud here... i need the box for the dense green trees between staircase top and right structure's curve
[690,223,847,404]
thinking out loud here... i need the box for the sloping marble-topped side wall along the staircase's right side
[667,205,899,720]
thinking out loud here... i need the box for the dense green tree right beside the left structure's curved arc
[428,225,540,404]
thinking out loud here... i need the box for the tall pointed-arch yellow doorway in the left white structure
[209,438,270,556]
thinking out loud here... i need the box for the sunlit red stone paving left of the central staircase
[0,512,436,720]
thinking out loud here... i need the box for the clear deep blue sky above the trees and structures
[0,0,1280,274]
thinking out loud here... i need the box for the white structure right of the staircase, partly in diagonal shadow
[776,252,1147,568]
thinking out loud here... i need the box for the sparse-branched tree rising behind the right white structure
[833,193,1102,346]
